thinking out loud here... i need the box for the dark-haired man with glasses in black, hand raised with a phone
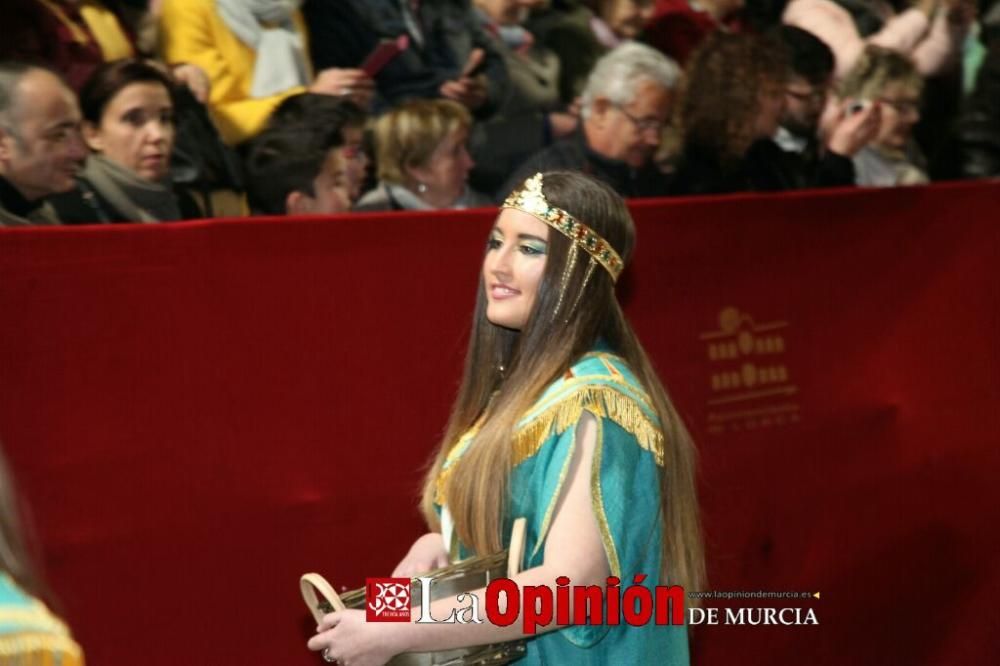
[774,25,880,187]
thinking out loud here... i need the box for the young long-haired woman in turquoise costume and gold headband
[309,172,704,666]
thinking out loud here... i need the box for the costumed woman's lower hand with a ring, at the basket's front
[307,610,409,666]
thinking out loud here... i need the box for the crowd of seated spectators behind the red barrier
[0,0,1000,225]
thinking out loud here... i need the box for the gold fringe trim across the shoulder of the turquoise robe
[514,384,663,467]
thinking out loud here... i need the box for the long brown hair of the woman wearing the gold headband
[422,172,704,589]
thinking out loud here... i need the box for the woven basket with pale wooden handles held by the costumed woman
[299,518,526,666]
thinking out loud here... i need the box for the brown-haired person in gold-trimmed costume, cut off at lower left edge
[0,449,83,666]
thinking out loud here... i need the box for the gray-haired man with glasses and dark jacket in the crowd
[498,42,680,199]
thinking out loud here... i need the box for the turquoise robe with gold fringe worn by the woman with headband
[439,352,689,666]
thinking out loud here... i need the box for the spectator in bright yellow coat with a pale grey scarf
[159,0,374,144]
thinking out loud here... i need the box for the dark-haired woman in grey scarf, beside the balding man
[52,60,201,224]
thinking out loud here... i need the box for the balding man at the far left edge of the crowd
[0,62,87,227]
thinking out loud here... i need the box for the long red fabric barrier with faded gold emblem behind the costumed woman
[0,184,1000,666]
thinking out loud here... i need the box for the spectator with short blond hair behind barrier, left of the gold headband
[354,99,490,211]
